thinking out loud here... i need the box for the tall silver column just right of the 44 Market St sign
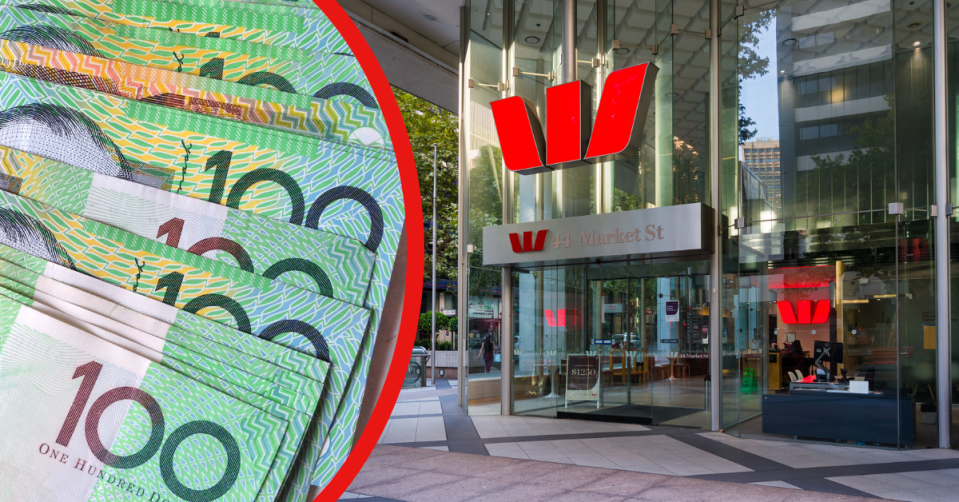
[709,0,724,431]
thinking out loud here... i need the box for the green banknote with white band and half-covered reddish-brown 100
[0,146,375,305]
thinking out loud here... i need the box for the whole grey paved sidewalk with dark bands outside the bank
[347,380,959,502]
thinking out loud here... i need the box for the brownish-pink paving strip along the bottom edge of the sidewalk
[350,445,869,502]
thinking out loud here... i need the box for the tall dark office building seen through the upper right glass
[771,0,908,222]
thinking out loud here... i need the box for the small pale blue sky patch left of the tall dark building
[741,21,779,140]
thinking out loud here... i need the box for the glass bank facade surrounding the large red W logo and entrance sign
[460,0,959,448]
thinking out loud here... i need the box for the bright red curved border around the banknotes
[314,0,424,502]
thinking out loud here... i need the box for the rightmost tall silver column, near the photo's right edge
[932,0,952,448]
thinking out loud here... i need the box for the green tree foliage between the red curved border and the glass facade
[393,88,459,282]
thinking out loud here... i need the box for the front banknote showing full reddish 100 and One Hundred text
[0,299,286,502]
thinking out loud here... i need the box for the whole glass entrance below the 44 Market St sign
[513,260,710,428]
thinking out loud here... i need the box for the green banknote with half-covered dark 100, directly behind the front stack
[0,186,369,426]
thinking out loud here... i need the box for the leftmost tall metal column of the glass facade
[456,3,470,406]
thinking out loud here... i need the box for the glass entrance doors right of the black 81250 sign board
[560,275,709,427]
